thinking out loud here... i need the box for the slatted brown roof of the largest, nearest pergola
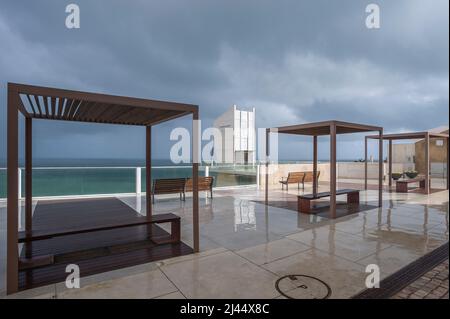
[9,83,198,126]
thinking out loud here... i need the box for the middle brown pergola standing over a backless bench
[265,120,383,218]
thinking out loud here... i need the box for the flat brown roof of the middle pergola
[269,120,383,136]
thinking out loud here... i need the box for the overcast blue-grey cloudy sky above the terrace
[0,0,449,164]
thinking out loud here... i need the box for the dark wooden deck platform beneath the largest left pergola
[19,198,193,290]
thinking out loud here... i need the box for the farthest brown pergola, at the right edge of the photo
[364,132,449,194]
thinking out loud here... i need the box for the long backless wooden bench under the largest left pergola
[18,213,180,270]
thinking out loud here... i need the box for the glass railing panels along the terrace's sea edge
[0,165,257,198]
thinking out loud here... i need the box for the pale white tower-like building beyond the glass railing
[214,105,256,164]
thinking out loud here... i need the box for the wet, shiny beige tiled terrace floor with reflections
[0,184,449,298]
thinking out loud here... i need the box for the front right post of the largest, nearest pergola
[192,110,200,253]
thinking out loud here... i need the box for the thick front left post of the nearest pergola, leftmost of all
[6,84,19,294]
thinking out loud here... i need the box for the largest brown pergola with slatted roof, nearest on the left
[7,83,199,294]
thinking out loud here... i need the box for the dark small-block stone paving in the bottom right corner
[392,259,448,299]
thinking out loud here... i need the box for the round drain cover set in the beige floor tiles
[275,275,331,299]
